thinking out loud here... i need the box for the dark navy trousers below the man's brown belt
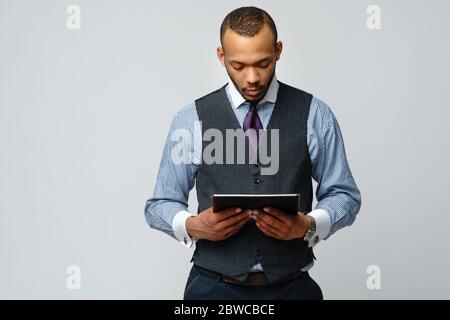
[183,265,323,300]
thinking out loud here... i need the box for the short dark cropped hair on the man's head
[220,7,278,47]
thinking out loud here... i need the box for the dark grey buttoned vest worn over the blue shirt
[191,82,314,283]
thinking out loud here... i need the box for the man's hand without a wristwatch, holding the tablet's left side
[186,208,250,241]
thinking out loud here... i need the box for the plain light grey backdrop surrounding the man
[0,0,450,299]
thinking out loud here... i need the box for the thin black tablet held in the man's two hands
[211,193,300,214]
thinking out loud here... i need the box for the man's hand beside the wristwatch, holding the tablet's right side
[250,207,308,240]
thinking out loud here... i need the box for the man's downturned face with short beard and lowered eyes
[217,25,283,102]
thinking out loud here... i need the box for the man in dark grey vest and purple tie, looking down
[145,7,361,299]
